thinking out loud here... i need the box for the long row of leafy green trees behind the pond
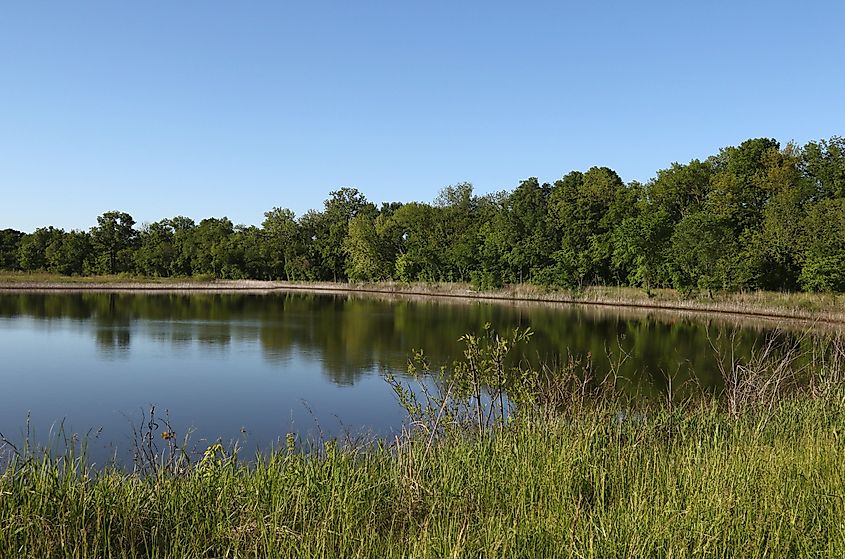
[0,137,845,292]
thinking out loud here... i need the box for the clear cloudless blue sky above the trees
[0,0,845,231]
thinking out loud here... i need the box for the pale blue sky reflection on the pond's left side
[0,317,402,461]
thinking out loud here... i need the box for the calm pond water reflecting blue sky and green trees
[0,292,800,461]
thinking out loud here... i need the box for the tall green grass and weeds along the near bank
[0,332,845,558]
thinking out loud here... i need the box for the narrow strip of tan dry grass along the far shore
[0,277,845,325]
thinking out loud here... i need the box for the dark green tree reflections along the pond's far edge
[0,293,812,392]
